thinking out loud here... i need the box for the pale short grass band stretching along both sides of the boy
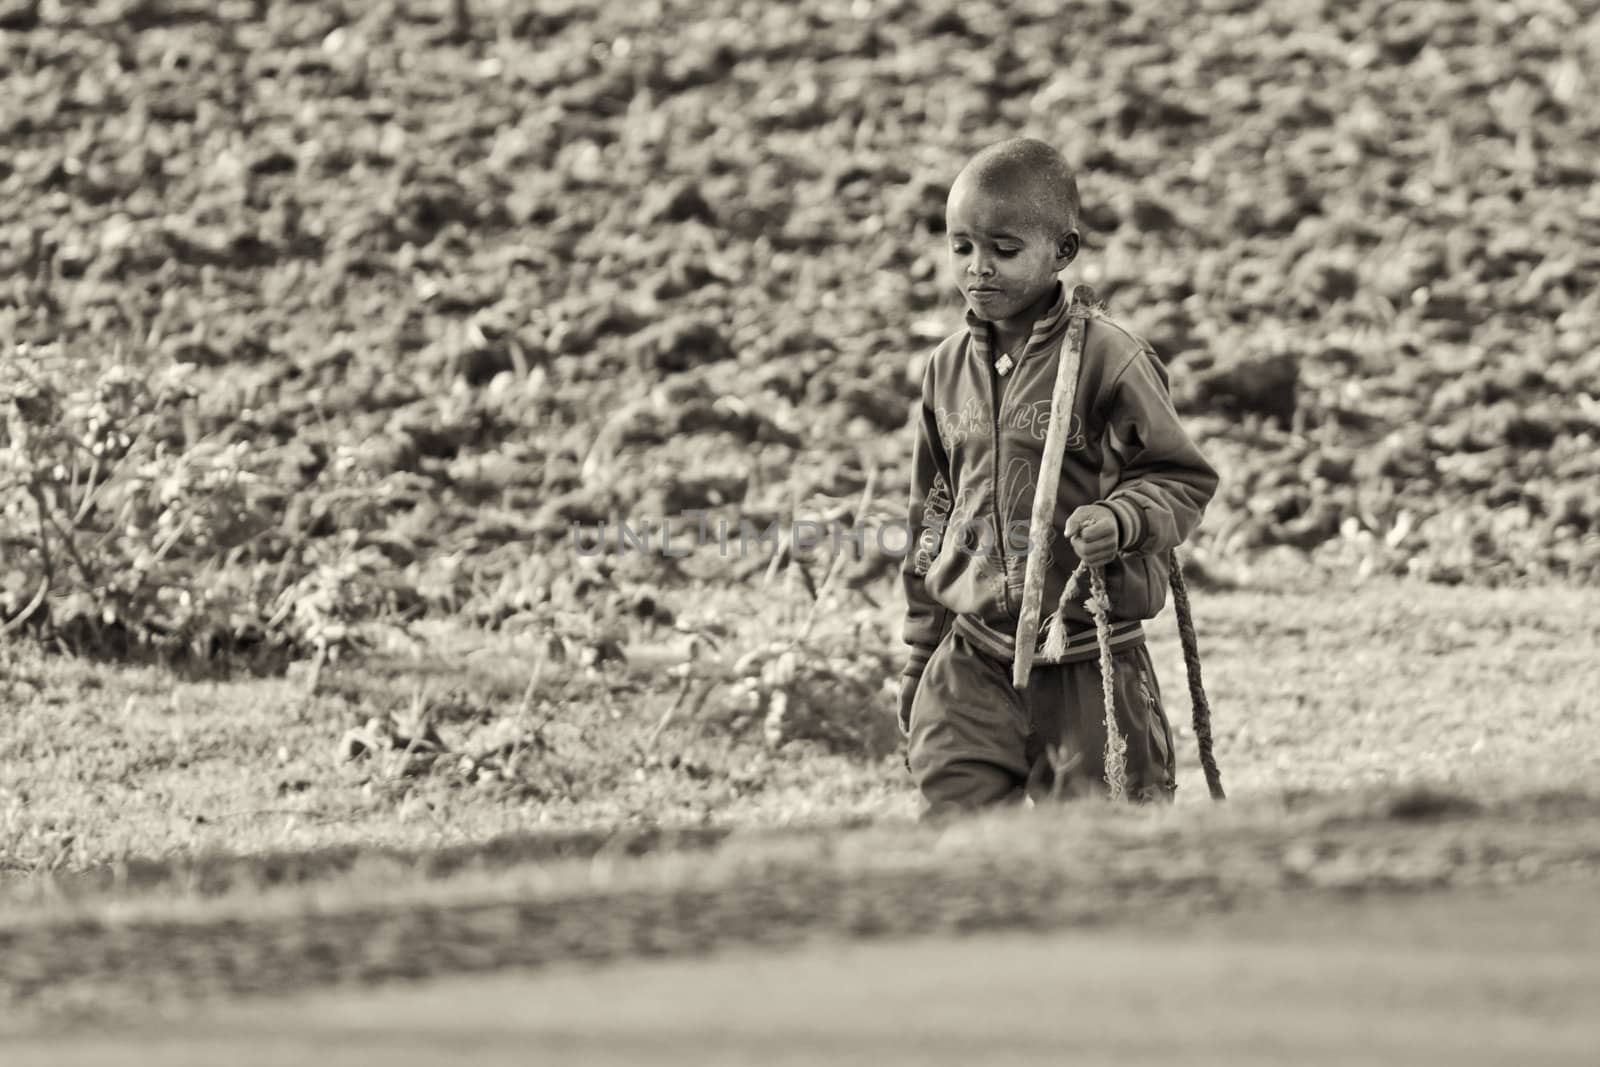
[0,584,1600,899]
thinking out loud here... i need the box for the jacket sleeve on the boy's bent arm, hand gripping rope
[1104,349,1218,555]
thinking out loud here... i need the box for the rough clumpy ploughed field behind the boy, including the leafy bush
[0,0,1600,671]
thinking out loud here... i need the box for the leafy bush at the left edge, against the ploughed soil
[0,346,296,657]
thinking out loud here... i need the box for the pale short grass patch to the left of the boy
[0,614,912,897]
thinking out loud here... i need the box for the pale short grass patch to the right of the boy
[1152,581,1600,803]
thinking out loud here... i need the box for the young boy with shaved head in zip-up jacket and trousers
[899,139,1218,814]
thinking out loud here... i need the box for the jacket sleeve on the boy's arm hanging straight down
[901,360,954,694]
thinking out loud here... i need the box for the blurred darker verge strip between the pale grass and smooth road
[0,792,1600,1021]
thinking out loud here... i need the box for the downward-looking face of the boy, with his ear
[944,176,1077,322]
